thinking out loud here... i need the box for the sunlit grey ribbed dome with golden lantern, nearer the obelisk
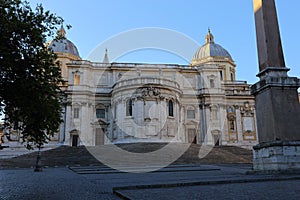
[192,30,232,64]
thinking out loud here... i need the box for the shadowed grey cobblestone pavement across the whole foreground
[0,165,300,200]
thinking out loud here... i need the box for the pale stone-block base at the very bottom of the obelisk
[253,141,300,172]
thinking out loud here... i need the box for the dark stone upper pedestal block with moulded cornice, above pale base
[251,67,300,143]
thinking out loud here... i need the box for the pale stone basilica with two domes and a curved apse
[4,28,258,148]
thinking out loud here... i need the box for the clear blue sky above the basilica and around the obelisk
[30,0,300,84]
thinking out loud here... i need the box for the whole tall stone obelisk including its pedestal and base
[251,0,300,171]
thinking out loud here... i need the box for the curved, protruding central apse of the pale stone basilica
[111,77,183,142]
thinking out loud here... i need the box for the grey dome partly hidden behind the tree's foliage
[48,27,80,58]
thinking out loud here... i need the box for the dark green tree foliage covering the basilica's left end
[0,0,63,148]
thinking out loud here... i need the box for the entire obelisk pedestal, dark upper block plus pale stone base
[251,67,300,173]
